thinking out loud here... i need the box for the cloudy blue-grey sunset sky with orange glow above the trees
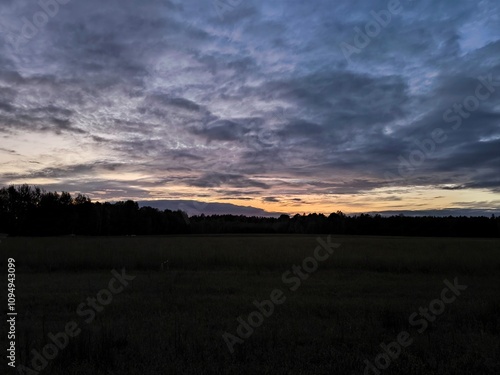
[0,0,500,214]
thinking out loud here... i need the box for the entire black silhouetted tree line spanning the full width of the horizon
[0,185,500,237]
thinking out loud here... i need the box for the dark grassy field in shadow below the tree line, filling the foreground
[0,236,500,375]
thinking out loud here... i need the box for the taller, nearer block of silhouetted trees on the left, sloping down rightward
[0,185,189,236]
